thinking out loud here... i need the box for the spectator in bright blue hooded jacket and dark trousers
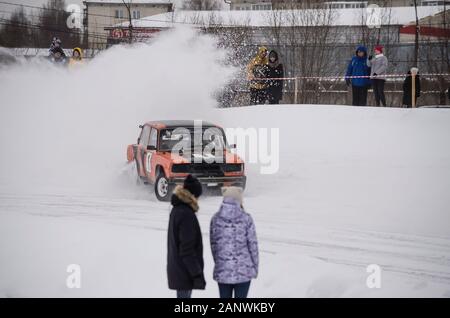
[345,45,370,106]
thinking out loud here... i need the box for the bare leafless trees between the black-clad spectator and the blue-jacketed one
[267,1,336,103]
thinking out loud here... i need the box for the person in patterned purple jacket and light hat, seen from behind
[209,187,259,298]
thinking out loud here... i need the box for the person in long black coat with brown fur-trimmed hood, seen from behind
[167,175,206,298]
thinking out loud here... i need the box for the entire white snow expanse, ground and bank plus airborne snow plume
[0,30,450,297]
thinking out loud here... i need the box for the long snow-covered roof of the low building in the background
[111,6,443,29]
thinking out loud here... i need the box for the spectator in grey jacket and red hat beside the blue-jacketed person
[367,45,388,106]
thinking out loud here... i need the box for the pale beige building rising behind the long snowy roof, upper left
[83,0,173,49]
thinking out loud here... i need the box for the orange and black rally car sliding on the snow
[127,120,246,201]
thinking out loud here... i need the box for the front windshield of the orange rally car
[159,127,226,151]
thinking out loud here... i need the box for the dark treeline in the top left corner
[0,0,83,48]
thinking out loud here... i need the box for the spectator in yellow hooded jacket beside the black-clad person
[247,46,268,105]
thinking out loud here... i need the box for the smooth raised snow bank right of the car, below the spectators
[221,105,450,237]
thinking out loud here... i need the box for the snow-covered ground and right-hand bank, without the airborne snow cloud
[0,105,450,297]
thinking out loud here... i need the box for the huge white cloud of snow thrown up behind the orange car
[0,27,234,195]
